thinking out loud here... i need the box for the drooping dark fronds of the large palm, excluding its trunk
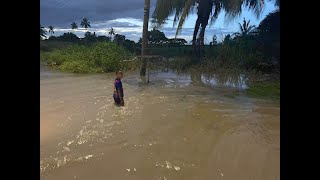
[152,0,266,39]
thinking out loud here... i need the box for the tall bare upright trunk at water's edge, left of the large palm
[140,0,150,76]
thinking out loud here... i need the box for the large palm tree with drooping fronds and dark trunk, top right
[153,0,272,52]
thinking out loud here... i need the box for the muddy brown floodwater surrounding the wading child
[40,67,280,180]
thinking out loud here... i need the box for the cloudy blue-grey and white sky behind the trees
[40,0,276,43]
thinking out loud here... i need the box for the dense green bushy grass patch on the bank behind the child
[40,42,132,73]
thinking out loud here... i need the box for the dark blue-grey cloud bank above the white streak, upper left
[40,0,155,28]
